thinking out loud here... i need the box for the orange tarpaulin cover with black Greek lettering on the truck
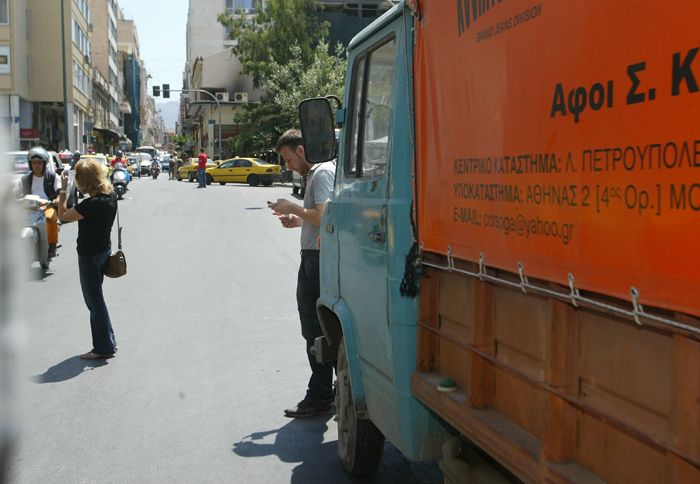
[414,0,700,316]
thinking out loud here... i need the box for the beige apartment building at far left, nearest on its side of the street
[0,0,92,150]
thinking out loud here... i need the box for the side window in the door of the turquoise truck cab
[345,39,396,178]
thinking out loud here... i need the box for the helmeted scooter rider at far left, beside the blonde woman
[18,146,61,258]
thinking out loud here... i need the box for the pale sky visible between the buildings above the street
[118,0,189,103]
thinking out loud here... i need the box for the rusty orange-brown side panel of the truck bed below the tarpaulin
[412,256,700,483]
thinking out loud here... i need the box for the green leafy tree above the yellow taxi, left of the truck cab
[219,0,346,155]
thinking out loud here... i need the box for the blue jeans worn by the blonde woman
[78,250,116,355]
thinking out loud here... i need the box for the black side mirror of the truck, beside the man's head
[299,98,337,163]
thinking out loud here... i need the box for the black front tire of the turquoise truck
[335,340,384,476]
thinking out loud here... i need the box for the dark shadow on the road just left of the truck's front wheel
[233,416,353,484]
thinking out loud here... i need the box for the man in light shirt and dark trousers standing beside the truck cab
[270,129,335,418]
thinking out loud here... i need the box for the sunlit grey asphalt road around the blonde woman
[12,174,442,483]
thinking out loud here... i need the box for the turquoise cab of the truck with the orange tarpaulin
[302,3,454,474]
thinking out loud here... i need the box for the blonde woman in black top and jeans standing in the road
[58,159,117,360]
